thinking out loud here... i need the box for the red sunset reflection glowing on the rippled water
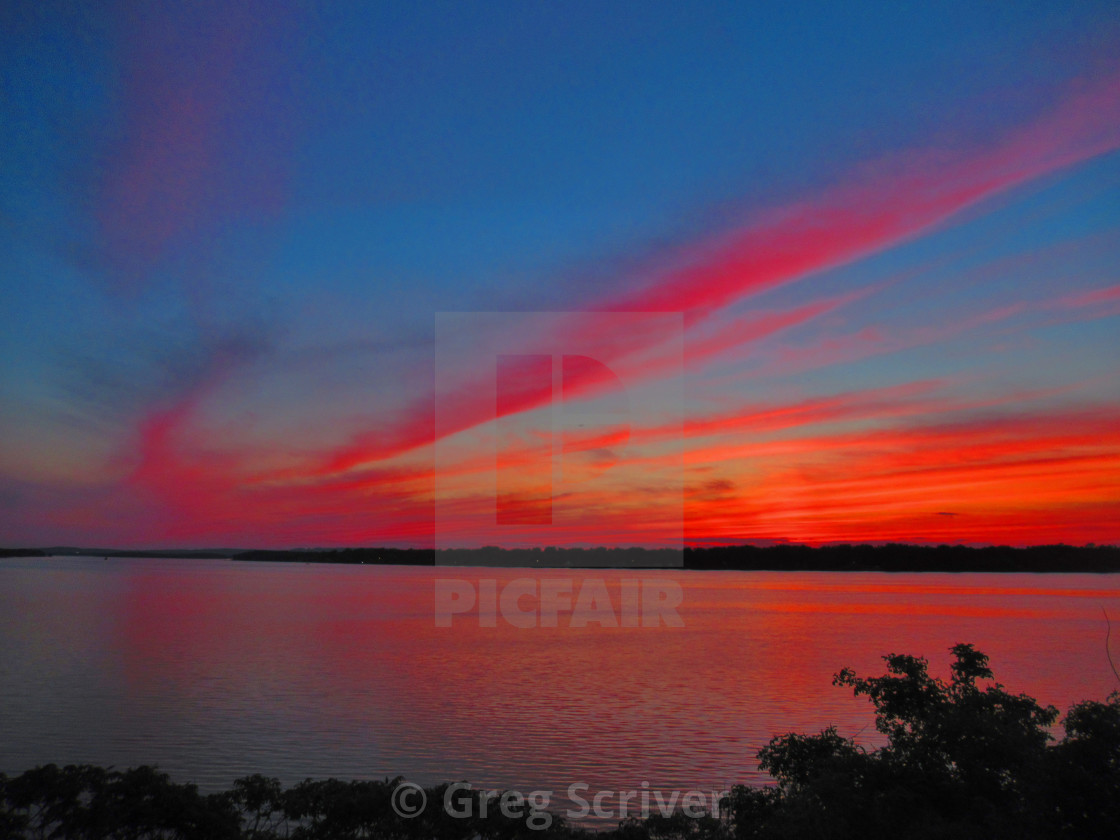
[103,563,1120,790]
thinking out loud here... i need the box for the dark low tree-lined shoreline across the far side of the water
[0,543,1120,573]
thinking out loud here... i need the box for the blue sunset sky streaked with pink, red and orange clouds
[0,0,1120,548]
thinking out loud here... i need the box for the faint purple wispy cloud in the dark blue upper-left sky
[86,2,293,293]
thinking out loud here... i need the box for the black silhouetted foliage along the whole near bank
[0,644,1120,840]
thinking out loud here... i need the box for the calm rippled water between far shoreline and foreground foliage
[0,558,1120,815]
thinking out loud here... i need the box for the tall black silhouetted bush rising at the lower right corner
[732,644,1120,840]
